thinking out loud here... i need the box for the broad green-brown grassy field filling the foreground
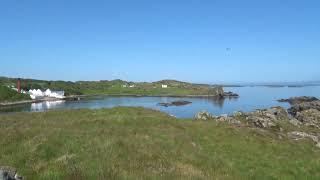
[0,107,320,179]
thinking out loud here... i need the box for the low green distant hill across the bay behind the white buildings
[0,77,223,96]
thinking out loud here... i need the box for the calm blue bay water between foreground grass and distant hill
[0,86,320,118]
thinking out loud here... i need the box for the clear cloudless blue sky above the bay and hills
[0,0,320,83]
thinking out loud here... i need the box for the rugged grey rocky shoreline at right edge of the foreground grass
[194,96,320,148]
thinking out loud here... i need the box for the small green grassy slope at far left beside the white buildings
[0,84,30,102]
